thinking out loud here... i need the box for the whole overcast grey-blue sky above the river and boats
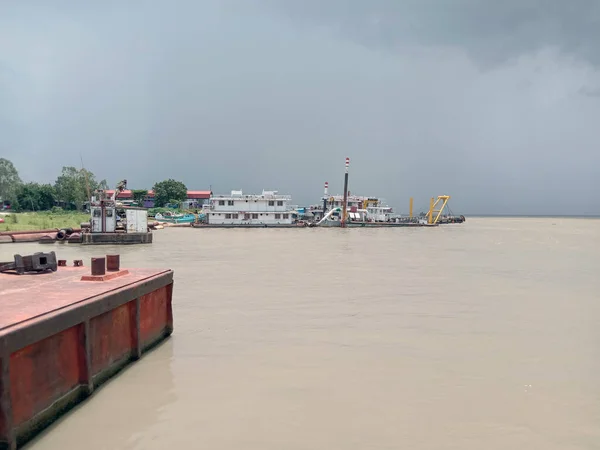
[0,0,600,215]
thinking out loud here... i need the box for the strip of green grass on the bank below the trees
[0,211,90,232]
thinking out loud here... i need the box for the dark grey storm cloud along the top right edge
[264,0,600,65]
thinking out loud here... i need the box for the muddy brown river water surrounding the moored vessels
[0,218,600,450]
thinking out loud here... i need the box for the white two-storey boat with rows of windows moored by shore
[203,190,296,226]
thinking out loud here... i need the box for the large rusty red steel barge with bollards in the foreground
[0,252,173,450]
